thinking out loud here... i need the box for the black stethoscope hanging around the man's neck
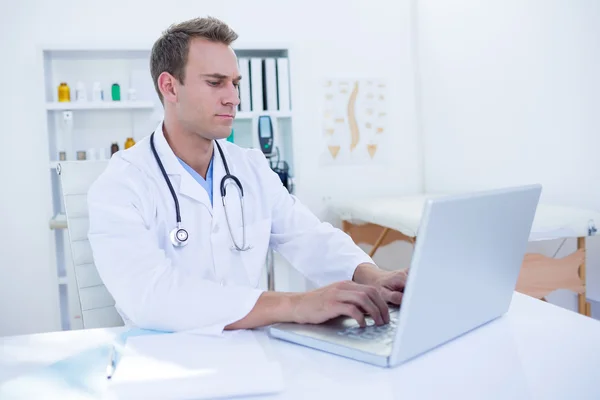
[150,132,252,251]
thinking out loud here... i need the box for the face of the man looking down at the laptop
[175,39,240,139]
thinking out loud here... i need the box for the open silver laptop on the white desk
[268,185,542,367]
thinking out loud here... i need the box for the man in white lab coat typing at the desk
[88,18,406,332]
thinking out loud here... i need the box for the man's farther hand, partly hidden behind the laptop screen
[353,264,408,305]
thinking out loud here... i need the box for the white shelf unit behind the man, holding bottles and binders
[40,46,293,330]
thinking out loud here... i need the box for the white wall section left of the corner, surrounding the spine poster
[0,0,421,335]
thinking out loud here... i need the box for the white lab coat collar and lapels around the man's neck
[154,121,225,212]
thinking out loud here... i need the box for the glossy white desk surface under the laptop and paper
[0,293,600,400]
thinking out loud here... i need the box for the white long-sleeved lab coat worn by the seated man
[88,123,372,332]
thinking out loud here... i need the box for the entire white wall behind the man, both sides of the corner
[5,0,600,335]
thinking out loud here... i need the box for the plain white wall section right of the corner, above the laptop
[417,0,600,306]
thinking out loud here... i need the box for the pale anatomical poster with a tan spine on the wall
[321,79,387,165]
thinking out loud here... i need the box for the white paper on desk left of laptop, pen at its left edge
[109,331,283,399]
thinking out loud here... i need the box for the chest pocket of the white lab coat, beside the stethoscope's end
[240,218,271,287]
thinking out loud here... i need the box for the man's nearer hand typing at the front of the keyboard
[291,281,390,327]
